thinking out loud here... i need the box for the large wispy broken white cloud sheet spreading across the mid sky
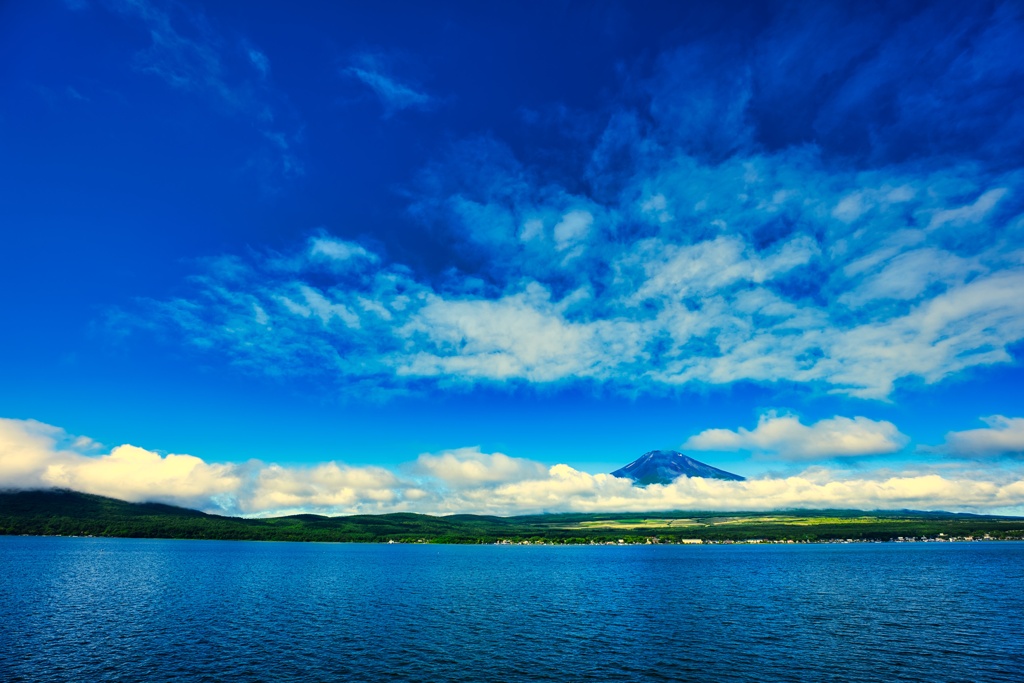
[119,74,1024,400]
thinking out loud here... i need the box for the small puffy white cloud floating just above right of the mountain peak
[682,413,909,461]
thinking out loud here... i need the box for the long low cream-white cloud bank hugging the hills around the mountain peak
[0,419,1024,515]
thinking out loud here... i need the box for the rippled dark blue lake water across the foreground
[0,537,1024,683]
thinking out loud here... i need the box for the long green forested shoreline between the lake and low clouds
[0,490,1024,544]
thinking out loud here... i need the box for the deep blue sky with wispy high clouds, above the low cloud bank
[0,0,1024,511]
